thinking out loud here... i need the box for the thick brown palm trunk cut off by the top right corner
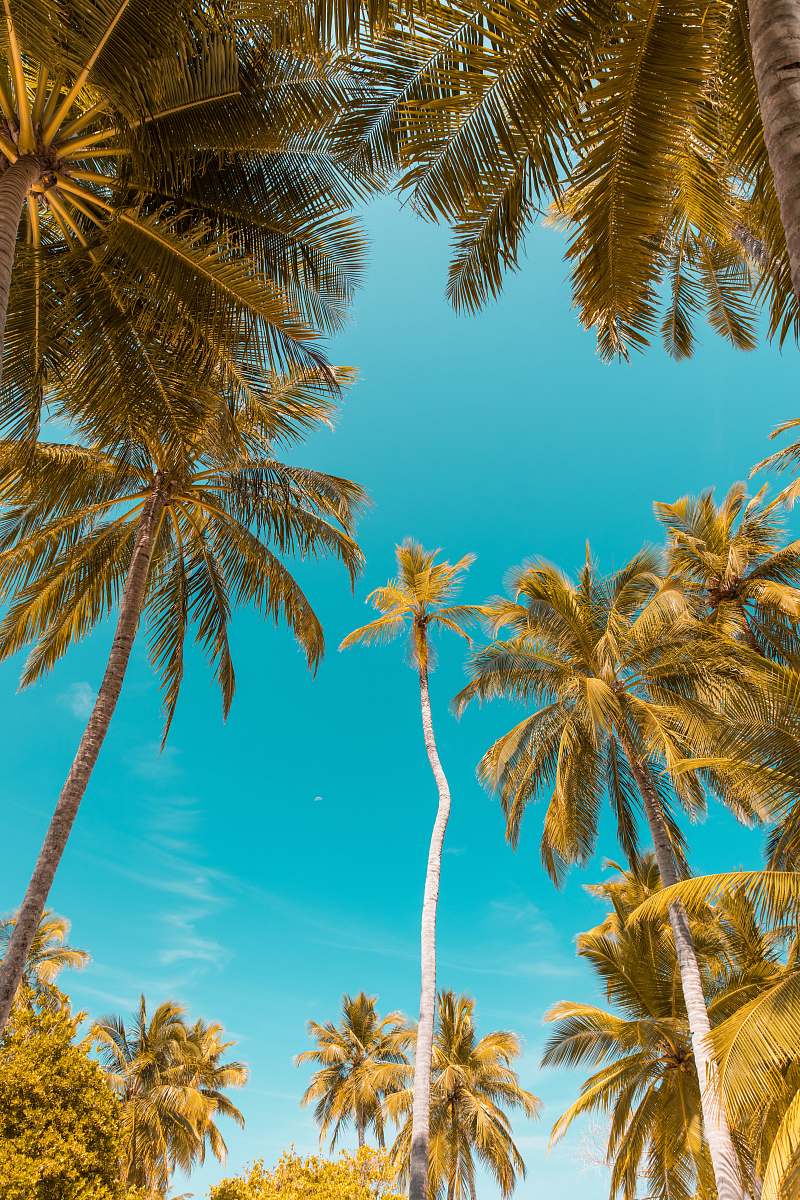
[748,0,800,299]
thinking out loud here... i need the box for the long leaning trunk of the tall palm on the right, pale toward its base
[621,737,745,1200]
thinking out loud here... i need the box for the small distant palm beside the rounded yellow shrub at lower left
[92,996,247,1193]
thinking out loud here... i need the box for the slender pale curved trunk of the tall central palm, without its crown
[408,666,450,1200]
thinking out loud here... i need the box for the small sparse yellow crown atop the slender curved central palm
[339,539,480,672]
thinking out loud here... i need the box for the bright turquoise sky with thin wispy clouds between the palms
[0,200,796,1200]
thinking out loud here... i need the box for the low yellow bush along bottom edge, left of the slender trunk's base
[209,1148,399,1200]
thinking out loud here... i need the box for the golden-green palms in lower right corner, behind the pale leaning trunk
[543,854,800,1200]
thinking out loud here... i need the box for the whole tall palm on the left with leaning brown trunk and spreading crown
[0,379,363,1028]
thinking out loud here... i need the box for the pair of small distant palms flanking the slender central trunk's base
[296,991,539,1200]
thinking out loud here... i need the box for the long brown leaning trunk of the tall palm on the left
[0,492,163,1033]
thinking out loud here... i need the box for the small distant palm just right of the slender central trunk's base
[386,991,540,1200]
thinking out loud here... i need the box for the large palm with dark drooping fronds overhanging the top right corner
[333,0,800,358]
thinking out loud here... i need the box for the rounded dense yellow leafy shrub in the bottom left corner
[0,1007,122,1200]
